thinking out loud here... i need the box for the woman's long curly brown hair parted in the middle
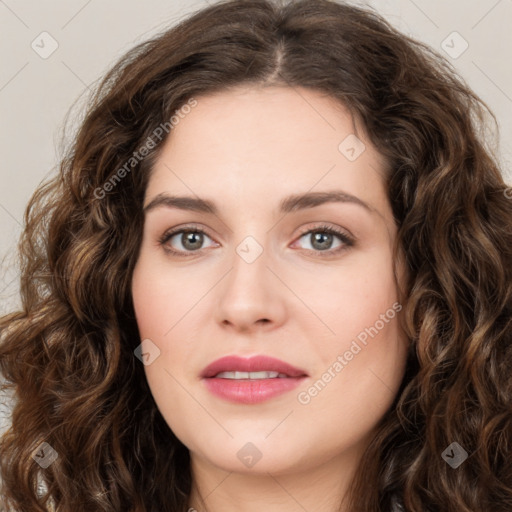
[0,0,512,512]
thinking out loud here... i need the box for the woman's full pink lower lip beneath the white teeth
[203,377,306,404]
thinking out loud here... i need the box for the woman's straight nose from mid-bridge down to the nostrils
[216,242,290,332]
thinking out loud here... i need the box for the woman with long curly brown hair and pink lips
[0,0,512,512]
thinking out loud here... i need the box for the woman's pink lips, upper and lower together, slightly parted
[200,356,308,404]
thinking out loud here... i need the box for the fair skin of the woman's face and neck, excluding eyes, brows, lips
[132,87,407,512]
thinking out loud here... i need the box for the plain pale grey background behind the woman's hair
[0,0,512,436]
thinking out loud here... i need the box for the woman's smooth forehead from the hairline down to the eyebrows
[146,87,386,222]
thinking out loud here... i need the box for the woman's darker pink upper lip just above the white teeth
[201,355,307,378]
